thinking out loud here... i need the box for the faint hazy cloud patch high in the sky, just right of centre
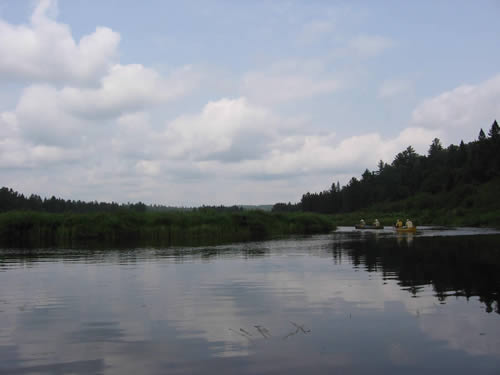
[242,60,341,103]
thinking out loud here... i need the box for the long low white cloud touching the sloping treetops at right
[195,128,440,179]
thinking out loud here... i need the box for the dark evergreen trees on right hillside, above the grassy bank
[273,120,500,214]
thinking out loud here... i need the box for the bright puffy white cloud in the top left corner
[0,0,120,82]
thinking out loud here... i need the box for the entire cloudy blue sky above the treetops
[0,0,500,206]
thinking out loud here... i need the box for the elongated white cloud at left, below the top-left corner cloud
[4,64,197,147]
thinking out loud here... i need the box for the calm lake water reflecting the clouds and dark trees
[0,228,500,375]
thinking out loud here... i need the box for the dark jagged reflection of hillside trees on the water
[332,235,500,313]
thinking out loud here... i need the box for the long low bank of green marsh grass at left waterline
[0,209,334,247]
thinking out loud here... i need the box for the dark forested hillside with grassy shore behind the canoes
[273,121,500,226]
